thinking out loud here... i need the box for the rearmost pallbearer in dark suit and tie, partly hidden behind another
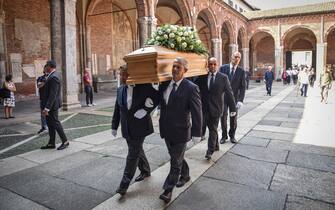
[220,51,245,144]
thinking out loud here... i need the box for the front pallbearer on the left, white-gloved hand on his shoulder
[112,65,159,195]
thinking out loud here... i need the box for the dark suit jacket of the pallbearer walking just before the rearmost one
[196,72,236,118]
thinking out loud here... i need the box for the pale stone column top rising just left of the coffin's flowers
[137,16,157,47]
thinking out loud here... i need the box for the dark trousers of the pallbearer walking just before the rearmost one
[203,113,220,153]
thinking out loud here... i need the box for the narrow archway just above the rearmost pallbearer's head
[221,21,233,64]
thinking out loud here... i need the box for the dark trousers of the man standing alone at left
[46,110,67,145]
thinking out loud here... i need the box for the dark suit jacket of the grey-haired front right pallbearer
[159,79,202,143]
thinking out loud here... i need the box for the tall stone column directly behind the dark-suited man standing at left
[50,0,80,110]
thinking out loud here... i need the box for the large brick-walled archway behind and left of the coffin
[86,0,138,76]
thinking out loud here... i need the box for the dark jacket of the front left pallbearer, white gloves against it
[112,84,159,140]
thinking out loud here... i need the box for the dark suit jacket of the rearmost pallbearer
[219,64,246,103]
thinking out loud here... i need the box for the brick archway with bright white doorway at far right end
[283,27,316,69]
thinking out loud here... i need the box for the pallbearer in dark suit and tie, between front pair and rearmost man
[196,57,236,160]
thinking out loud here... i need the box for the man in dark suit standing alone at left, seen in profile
[41,60,69,150]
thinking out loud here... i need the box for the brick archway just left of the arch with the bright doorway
[249,31,275,79]
